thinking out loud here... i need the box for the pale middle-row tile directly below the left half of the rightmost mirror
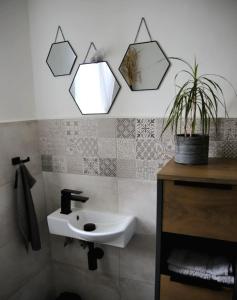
[117,139,136,159]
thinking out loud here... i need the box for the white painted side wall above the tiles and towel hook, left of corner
[0,0,35,122]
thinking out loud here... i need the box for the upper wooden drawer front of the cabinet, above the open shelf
[163,180,237,241]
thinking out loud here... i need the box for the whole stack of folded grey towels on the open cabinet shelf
[167,249,234,284]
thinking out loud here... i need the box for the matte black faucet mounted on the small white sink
[61,189,89,215]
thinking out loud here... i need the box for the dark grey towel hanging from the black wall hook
[15,164,41,251]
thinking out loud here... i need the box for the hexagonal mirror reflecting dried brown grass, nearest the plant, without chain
[119,41,170,91]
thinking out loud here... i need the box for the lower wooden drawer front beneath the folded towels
[160,275,233,300]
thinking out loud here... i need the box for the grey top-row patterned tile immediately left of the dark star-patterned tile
[116,119,136,139]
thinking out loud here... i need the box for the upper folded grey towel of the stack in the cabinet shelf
[167,249,233,276]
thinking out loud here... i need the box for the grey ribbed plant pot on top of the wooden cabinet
[175,134,209,165]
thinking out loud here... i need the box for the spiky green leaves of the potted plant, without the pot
[162,57,234,136]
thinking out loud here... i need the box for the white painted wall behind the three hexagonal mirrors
[28,0,237,119]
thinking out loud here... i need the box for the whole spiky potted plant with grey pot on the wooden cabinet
[162,57,233,164]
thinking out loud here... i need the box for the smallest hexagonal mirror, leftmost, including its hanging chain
[46,26,77,77]
